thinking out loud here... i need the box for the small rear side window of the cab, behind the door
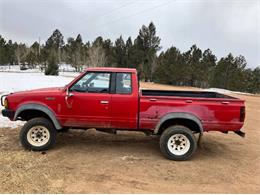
[116,73,132,94]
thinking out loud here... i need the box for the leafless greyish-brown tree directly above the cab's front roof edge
[88,44,107,67]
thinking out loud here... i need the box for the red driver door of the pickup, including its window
[65,72,111,128]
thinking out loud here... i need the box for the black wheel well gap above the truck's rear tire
[158,118,201,135]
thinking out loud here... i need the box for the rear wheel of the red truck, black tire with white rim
[160,125,197,161]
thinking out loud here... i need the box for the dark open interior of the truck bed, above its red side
[141,89,236,99]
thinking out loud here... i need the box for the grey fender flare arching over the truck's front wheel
[14,103,62,129]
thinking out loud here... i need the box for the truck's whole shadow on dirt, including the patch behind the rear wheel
[54,130,233,160]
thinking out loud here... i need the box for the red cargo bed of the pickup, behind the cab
[139,89,244,131]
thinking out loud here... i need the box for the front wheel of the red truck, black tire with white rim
[20,118,57,151]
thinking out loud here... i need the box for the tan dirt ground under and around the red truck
[0,84,260,193]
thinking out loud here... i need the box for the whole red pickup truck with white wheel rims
[1,68,245,160]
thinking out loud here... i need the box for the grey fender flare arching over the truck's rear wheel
[154,112,203,134]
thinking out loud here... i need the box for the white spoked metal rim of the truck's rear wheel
[167,134,190,156]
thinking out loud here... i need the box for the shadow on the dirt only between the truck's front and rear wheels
[55,130,160,152]
